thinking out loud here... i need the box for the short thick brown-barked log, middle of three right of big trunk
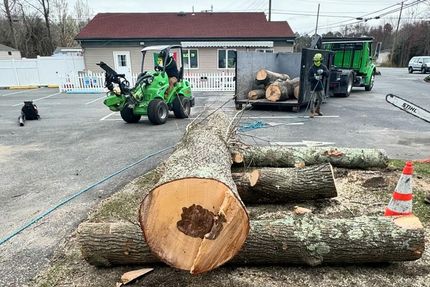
[233,163,337,203]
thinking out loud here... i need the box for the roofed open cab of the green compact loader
[141,45,184,81]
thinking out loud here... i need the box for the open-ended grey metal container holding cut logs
[235,49,333,111]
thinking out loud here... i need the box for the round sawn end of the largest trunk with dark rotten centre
[139,178,249,274]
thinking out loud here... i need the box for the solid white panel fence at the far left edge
[0,56,85,87]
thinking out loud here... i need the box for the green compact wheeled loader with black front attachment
[97,45,194,125]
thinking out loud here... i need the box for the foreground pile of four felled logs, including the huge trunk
[78,113,425,274]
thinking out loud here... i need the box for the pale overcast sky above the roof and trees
[75,0,430,33]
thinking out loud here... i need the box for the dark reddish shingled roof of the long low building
[76,12,294,40]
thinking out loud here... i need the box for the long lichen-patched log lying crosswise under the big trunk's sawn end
[78,214,425,267]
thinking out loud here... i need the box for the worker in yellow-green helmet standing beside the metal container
[308,53,329,118]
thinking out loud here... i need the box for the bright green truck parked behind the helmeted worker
[322,37,376,97]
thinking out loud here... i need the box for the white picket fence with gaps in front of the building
[60,72,235,93]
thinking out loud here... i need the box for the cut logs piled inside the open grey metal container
[248,69,300,102]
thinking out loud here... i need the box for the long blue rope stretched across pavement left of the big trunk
[0,146,174,248]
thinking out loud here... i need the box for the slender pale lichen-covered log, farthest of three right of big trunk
[231,146,388,169]
